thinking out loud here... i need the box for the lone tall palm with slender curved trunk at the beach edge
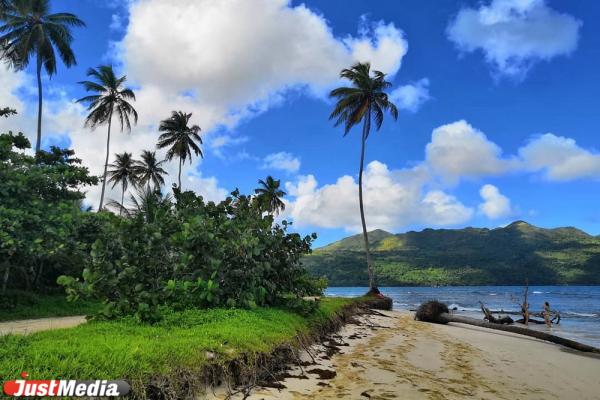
[329,63,398,289]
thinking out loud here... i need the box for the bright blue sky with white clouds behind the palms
[0,0,600,246]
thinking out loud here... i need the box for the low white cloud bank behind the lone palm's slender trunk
[286,161,473,232]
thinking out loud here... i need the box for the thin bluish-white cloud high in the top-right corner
[447,0,582,78]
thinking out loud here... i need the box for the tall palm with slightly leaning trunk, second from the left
[77,65,138,211]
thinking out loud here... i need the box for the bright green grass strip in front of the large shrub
[0,298,354,394]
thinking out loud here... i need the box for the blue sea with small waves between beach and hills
[325,286,600,347]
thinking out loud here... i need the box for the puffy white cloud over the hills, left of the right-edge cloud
[425,120,513,183]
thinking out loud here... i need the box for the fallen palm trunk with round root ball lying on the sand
[415,301,600,354]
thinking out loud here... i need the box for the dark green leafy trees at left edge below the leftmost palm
[0,133,102,294]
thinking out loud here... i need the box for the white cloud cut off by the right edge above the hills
[519,133,600,181]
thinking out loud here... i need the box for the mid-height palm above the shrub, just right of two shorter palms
[157,111,204,190]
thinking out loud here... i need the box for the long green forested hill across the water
[304,221,600,286]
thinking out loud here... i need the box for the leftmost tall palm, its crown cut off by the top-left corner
[0,0,85,152]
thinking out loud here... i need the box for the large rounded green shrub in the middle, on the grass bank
[59,190,323,321]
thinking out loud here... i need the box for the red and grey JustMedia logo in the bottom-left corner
[4,372,131,397]
